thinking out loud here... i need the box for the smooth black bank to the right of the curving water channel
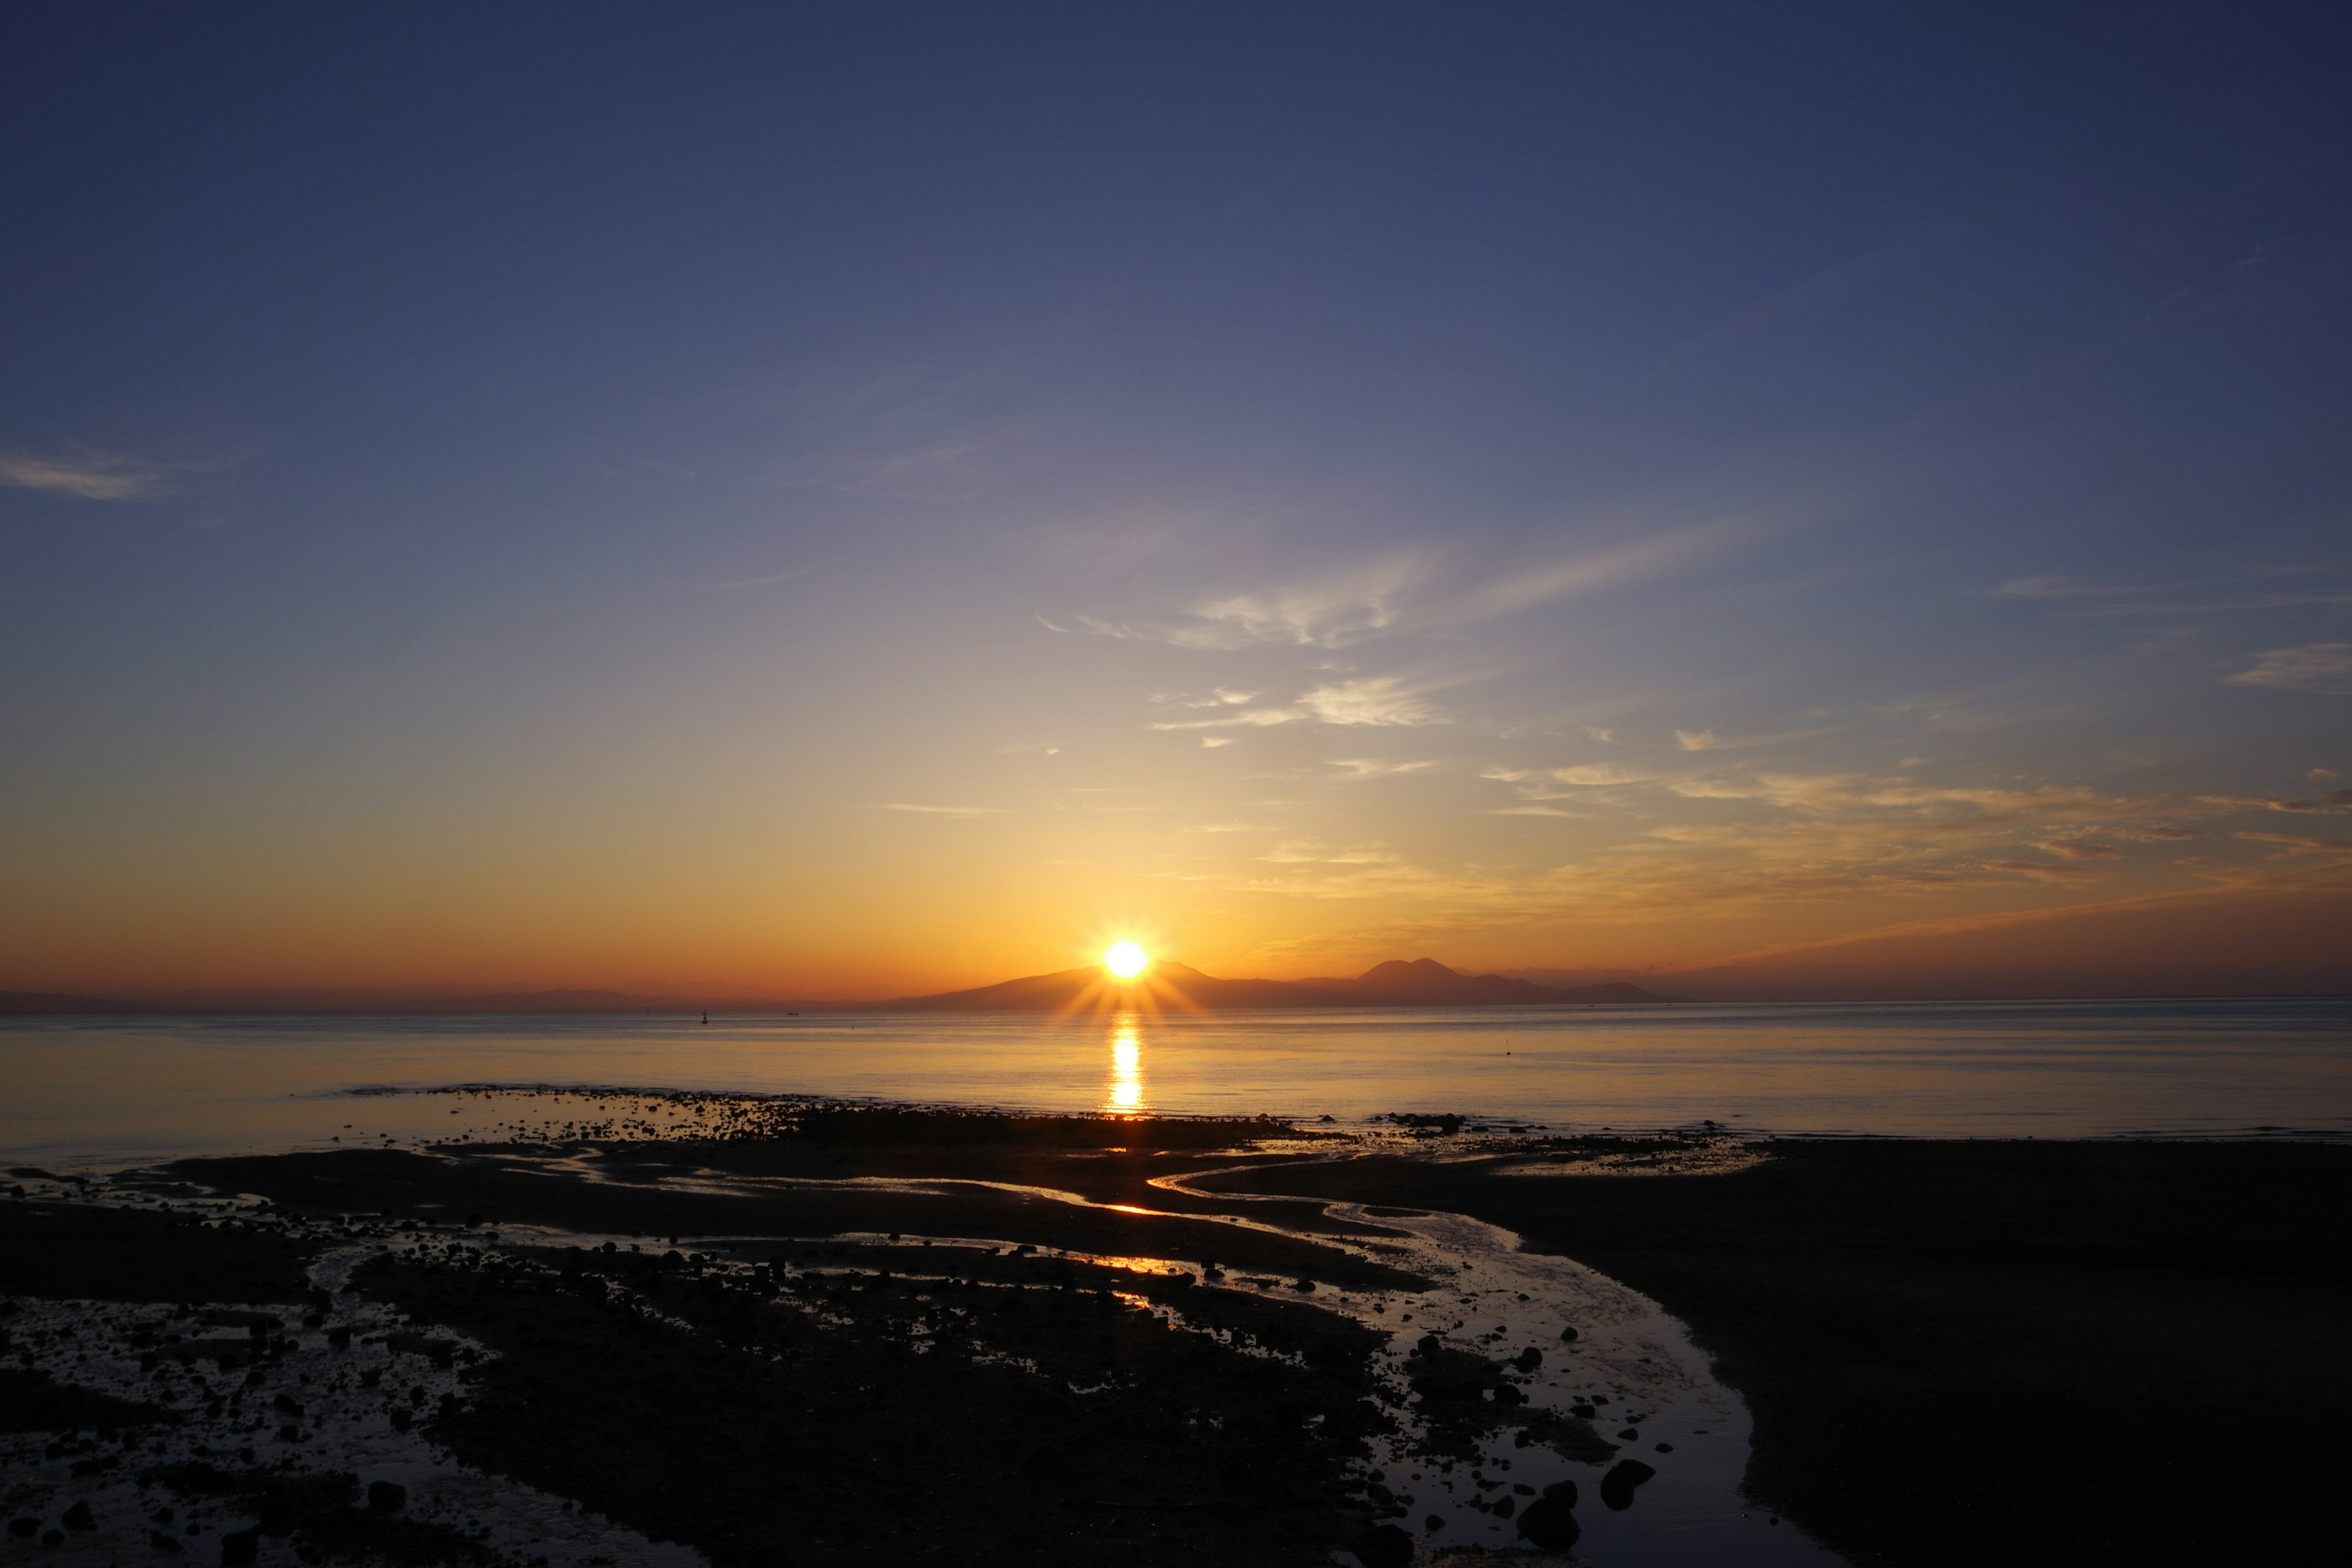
[1216,1138,2352,1568]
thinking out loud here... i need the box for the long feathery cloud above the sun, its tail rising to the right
[1037,519,1755,651]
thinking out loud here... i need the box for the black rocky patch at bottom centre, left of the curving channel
[358,1248,1390,1568]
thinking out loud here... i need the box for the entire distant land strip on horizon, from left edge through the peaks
[0,959,1668,1013]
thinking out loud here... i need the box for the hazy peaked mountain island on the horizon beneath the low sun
[861,959,1665,1013]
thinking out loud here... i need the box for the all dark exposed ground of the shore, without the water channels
[0,1096,2352,1566]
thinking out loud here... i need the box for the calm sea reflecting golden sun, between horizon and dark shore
[0,999,2352,1166]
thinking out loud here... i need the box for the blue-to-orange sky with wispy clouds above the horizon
[0,0,2352,997]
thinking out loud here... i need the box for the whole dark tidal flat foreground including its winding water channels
[0,1088,2352,1568]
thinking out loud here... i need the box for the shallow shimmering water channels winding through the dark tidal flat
[0,1147,1839,1568]
